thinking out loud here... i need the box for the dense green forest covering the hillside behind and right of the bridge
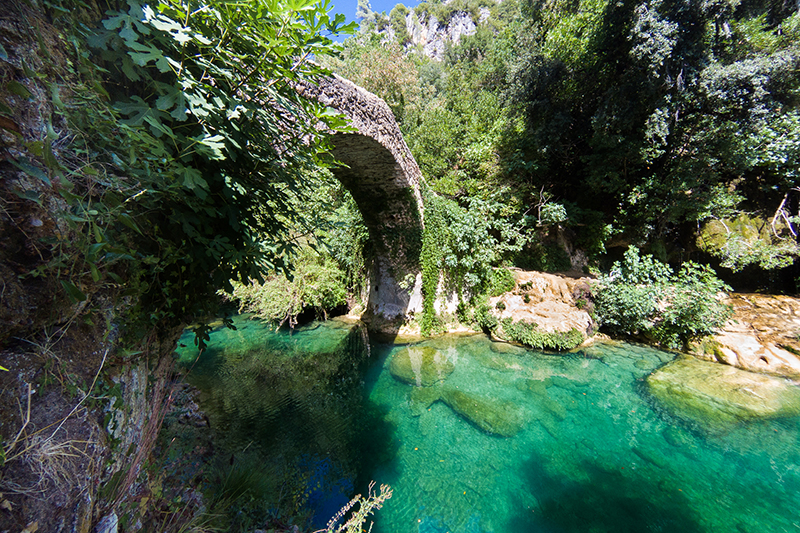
[342,0,800,291]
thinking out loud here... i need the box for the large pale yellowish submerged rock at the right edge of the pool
[647,357,800,431]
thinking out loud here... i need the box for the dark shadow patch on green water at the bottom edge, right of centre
[506,457,704,533]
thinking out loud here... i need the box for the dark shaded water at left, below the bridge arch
[173,316,404,528]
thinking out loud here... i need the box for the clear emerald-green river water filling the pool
[175,316,800,533]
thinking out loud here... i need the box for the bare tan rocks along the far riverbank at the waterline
[374,269,800,381]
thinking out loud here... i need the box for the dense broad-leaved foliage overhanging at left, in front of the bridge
[7,0,354,338]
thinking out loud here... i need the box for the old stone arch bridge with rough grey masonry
[299,75,423,329]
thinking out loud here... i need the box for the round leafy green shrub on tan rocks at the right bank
[597,246,731,348]
